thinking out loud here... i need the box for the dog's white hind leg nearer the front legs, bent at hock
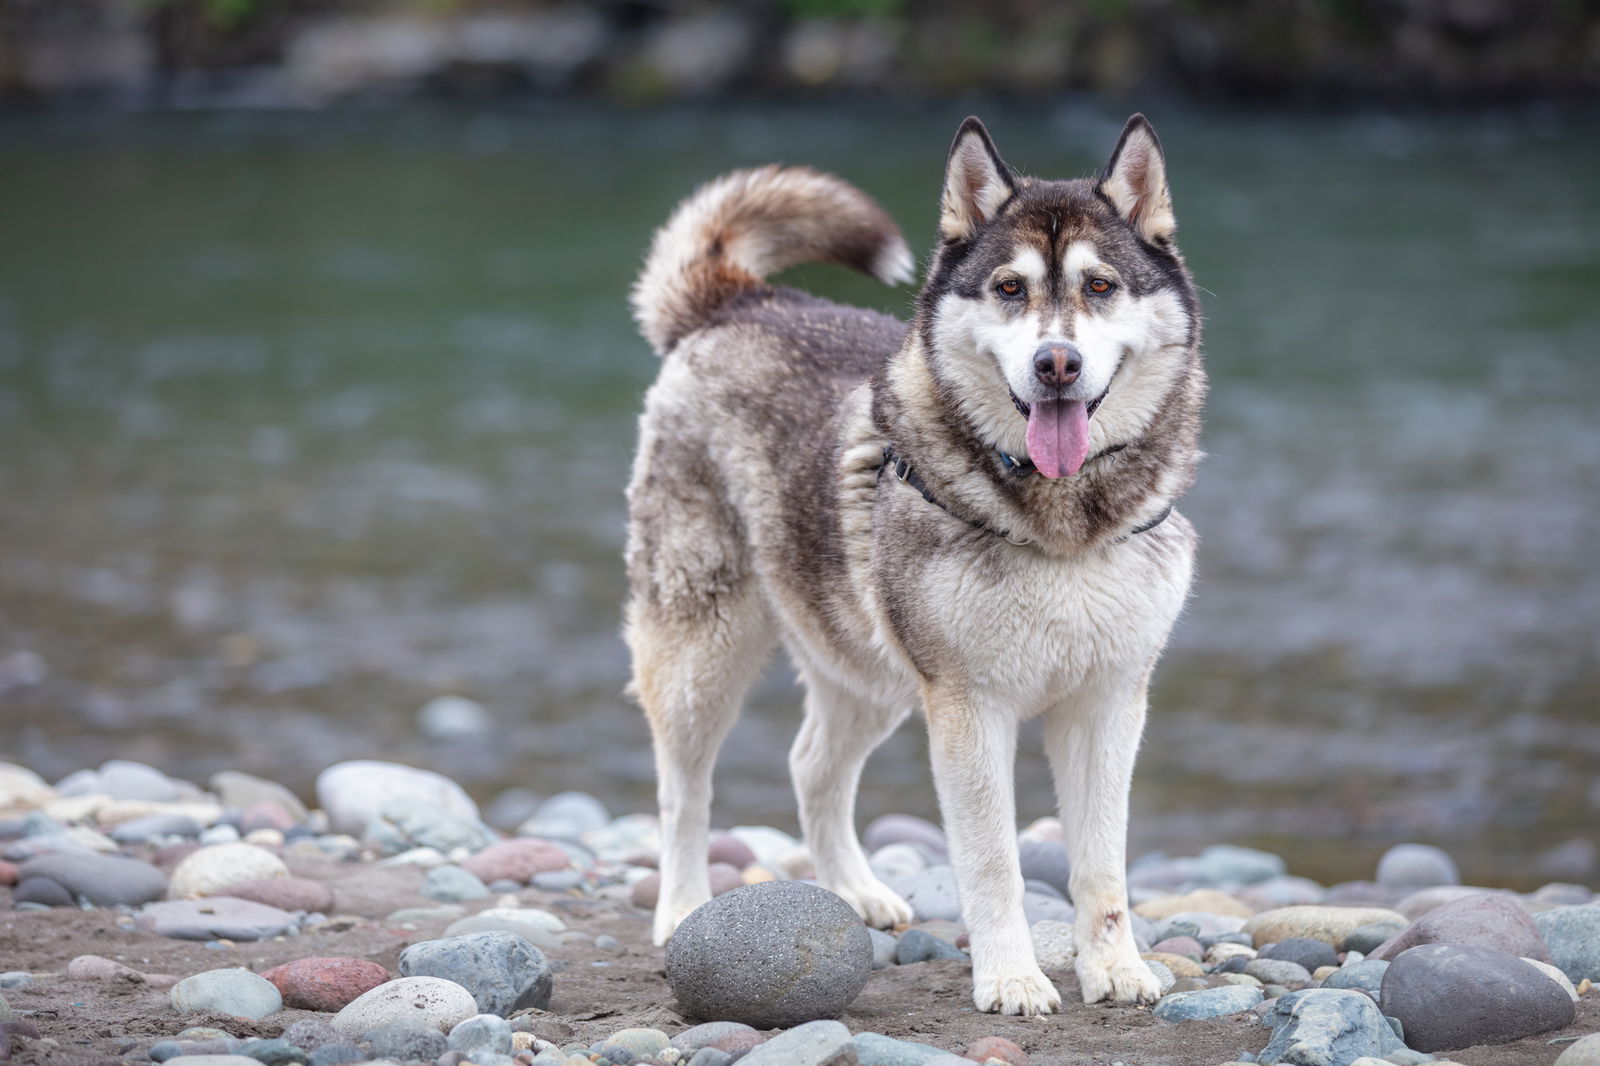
[789,671,912,928]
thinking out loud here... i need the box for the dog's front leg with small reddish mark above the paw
[1045,679,1160,1004]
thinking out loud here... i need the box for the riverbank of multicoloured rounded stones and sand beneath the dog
[0,762,1600,1066]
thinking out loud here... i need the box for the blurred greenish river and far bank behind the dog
[0,0,1600,888]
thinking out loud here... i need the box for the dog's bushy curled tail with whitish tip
[634,166,914,355]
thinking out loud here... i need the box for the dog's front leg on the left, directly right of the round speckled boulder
[925,690,1061,1015]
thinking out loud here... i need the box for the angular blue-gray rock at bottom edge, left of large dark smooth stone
[1258,988,1405,1066]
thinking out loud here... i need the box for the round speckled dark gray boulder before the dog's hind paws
[667,880,872,1039]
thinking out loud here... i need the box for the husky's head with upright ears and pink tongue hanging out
[918,115,1198,477]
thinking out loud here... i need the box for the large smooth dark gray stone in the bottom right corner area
[1382,944,1576,1052]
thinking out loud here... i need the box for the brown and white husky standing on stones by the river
[624,115,1206,1015]
